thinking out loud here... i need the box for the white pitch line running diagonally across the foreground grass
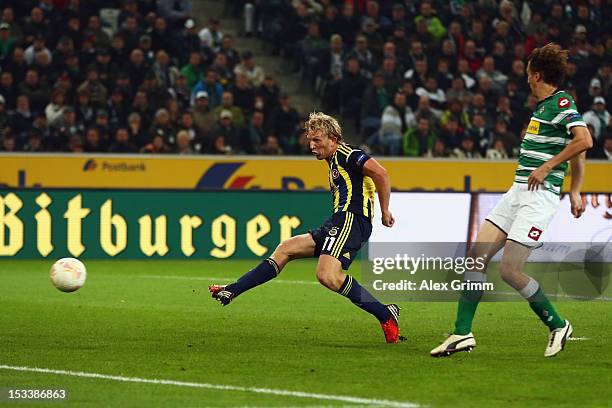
[0,364,419,408]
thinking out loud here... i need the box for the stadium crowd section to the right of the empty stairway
[250,0,612,159]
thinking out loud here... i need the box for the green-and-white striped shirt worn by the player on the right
[514,91,586,195]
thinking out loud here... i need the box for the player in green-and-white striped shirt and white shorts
[431,43,593,357]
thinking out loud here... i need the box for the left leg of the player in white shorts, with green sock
[430,220,506,357]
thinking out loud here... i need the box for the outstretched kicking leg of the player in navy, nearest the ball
[208,234,315,305]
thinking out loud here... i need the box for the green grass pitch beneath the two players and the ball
[0,260,612,407]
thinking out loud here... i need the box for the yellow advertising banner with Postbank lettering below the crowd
[0,154,612,192]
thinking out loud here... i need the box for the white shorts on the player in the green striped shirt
[485,183,560,248]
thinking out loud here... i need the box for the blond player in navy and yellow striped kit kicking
[209,112,399,343]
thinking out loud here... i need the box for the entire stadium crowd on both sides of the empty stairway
[0,0,612,159]
